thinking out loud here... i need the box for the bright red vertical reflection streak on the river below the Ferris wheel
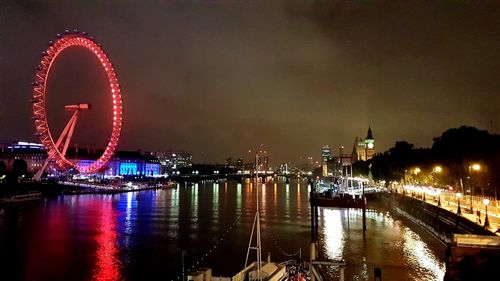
[93,201,120,281]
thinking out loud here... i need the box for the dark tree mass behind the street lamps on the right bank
[353,126,500,195]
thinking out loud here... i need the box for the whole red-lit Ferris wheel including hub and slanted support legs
[33,30,122,180]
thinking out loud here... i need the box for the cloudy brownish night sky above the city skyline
[0,0,500,164]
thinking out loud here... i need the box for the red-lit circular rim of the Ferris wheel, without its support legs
[33,33,122,173]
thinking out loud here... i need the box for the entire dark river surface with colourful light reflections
[0,181,445,280]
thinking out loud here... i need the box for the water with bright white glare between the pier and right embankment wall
[319,208,445,281]
